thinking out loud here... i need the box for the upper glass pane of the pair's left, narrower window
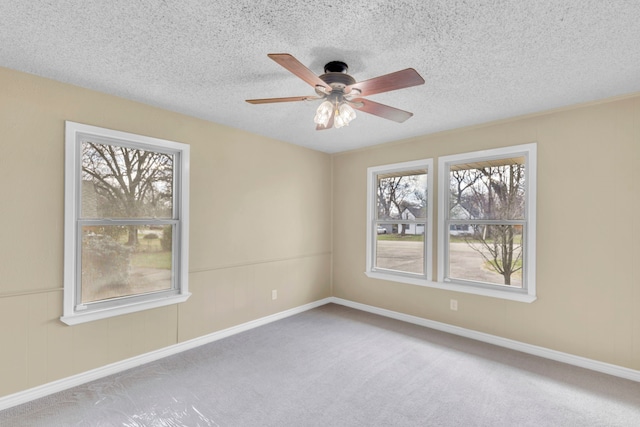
[376,172,427,220]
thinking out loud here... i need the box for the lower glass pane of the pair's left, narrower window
[375,232,425,274]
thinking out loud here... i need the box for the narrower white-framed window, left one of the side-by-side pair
[366,159,432,285]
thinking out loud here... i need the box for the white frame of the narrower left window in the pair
[365,159,433,286]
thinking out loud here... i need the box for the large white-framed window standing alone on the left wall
[61,122,190,325]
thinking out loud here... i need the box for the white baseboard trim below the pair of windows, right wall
[329,297,640,382]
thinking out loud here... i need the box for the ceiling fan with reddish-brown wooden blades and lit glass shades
[247,53,424,130]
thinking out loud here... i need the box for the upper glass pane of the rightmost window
[449,156,525,220]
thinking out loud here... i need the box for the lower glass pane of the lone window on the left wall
[81,225,173,303]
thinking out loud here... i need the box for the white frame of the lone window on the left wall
[60,121,191,325]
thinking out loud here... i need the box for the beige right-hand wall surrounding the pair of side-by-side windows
[333,97,640,369]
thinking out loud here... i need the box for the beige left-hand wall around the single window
[0,68,331,396]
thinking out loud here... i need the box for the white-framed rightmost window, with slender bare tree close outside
[438,144,536,302]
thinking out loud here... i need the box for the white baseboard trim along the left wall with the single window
[0,298,332,411]
